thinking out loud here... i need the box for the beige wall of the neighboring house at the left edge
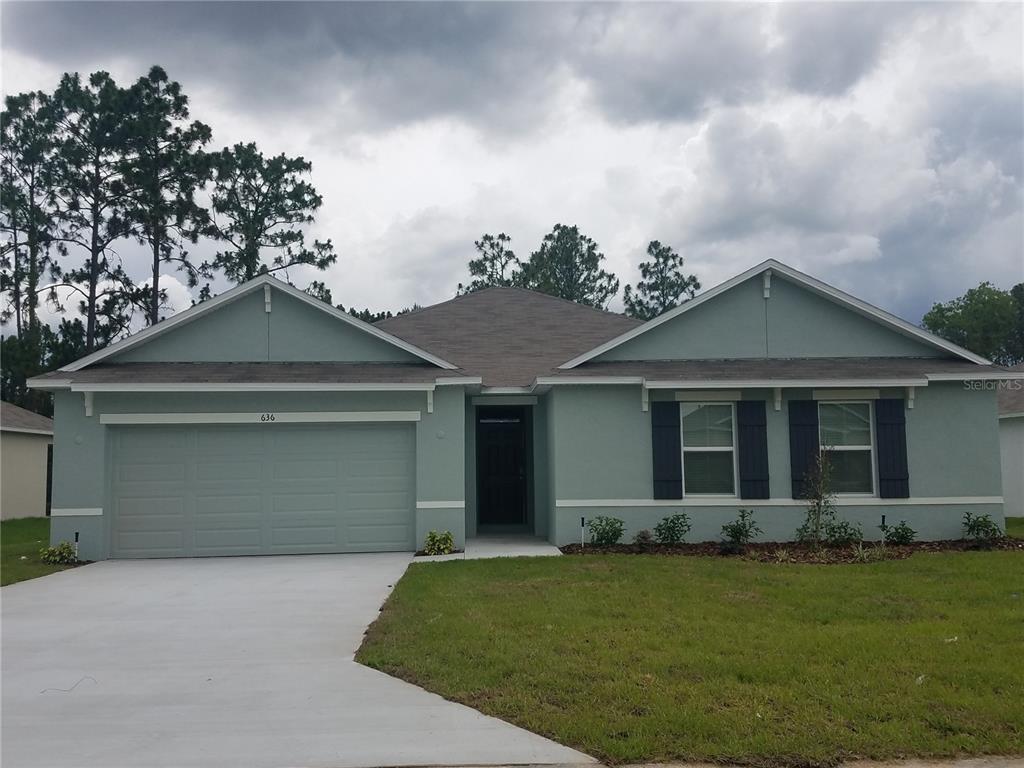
[0,432,50,520]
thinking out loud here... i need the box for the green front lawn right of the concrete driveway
[356,552,1024,766]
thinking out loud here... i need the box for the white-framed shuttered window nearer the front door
[679,402,736,496]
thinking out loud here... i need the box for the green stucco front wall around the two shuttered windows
[548,383,1002,544]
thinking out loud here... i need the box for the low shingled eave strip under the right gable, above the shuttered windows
[542,357,1011,387]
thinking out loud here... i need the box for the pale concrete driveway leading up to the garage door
[0,554,590,768]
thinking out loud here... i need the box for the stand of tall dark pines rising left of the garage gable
[0,67,337,411]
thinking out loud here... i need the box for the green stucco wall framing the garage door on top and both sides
[44,387,465,560]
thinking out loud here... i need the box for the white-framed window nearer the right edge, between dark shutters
[818,400,874,495]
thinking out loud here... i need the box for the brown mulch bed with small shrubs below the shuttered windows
[559,538,1024,565]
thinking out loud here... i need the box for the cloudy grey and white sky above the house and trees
[0,2,1024,322]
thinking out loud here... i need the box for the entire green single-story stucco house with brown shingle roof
[32,261,1020,560]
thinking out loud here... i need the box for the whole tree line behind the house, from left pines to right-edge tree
[0,67,1024,413]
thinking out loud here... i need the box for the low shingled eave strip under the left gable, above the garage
[32,362,478,391]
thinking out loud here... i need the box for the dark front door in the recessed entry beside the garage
[476,406,527,525]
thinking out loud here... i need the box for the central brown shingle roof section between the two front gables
[377,287,641,387]
